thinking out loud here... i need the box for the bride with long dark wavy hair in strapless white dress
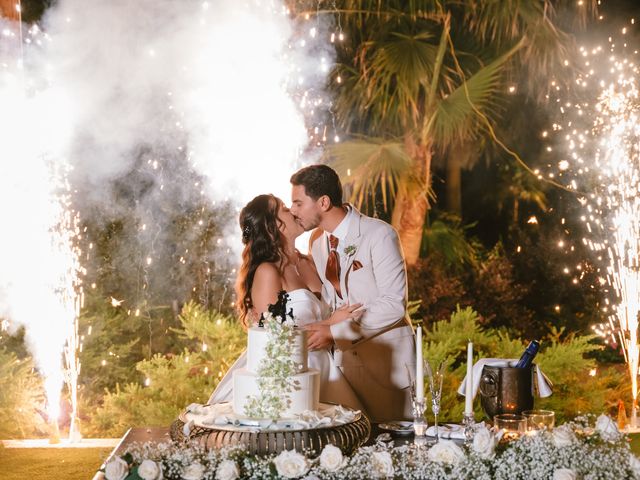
[209,195,364,410]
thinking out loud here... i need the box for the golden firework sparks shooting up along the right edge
[542,18,640,412]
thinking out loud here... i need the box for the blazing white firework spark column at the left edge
[0,10,80,437]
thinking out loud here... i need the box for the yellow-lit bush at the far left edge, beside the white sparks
[0,348,47,438]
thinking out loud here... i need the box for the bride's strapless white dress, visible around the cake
[209,288,364,410]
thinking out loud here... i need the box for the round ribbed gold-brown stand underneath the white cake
[171,404,371,455]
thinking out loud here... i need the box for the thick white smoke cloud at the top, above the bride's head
[40,0,307,203]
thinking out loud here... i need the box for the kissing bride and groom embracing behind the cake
[209,165,416,422]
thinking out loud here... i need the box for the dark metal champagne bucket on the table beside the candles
[480,365,534,420]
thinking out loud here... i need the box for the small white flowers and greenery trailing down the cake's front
[244,312,297,420]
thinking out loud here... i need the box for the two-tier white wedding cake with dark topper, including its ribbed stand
[171,292,371,455]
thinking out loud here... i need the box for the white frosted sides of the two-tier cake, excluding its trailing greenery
[233,326,320,418]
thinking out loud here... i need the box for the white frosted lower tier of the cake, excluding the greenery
[233,368,320,418]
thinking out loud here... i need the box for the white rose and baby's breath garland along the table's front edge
[105,415,640,480]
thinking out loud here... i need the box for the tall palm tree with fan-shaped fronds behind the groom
[298,0,595,265]
